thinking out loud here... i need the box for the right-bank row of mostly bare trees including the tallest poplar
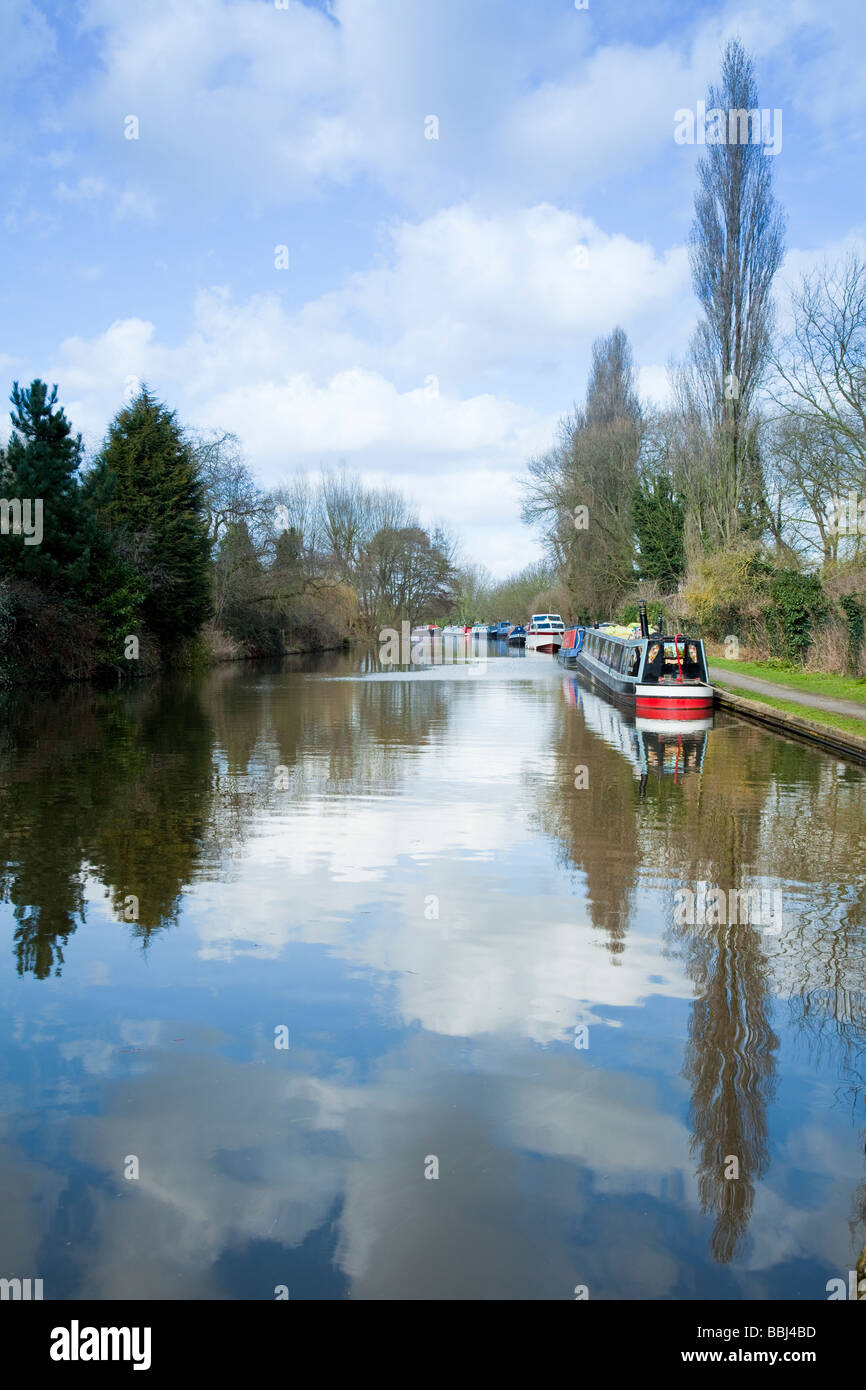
[523,40,866,670]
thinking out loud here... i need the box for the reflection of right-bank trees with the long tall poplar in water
[539,688,866,1262]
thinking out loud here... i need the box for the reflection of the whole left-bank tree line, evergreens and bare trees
[0,667,449,980]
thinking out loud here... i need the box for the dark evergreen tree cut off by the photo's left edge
[0,378,96,594]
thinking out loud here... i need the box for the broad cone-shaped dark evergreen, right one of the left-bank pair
[88,386,210,653]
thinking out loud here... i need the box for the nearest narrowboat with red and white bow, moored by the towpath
[570,606,713,720]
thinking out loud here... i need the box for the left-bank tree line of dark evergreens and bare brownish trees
[0,379,459,684]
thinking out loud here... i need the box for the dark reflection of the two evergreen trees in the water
[0,682,210,979]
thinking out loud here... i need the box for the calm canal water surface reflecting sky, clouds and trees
[0,653,866,1300]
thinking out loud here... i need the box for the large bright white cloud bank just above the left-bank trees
[48,204,691,455]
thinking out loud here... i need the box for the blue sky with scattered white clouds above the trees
[0,0,866,577]
